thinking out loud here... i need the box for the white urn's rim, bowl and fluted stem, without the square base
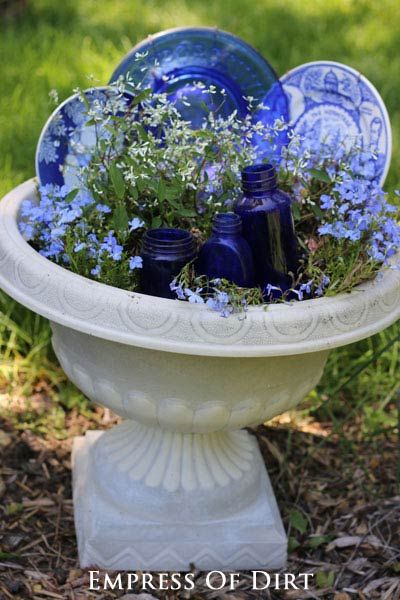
[0,180,400,564]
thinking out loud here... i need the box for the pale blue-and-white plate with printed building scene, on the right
[281,61,392,185]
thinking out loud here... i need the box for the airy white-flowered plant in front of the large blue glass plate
[71,78,283,225]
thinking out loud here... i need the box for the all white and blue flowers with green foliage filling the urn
[25,91,400,300]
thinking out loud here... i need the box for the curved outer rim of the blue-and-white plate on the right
[280,60,392,185]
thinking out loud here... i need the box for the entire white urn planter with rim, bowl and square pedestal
[0,180,400,571]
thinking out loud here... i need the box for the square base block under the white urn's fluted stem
[72,431,287,571]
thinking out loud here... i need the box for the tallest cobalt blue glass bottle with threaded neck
[235,164,298,291]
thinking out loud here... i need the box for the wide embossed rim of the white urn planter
[0,179,400,356]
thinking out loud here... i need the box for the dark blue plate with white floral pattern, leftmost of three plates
[35,87,133,189]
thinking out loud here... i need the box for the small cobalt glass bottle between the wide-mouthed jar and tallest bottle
[196,213,254,287]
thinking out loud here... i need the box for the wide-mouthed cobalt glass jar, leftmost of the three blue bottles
[140,228,196,298]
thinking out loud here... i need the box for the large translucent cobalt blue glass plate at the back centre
[110,27,288,158]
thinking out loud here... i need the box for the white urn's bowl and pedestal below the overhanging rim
[52,323,327,570]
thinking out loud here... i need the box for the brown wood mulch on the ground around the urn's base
[0,409,400,600]
